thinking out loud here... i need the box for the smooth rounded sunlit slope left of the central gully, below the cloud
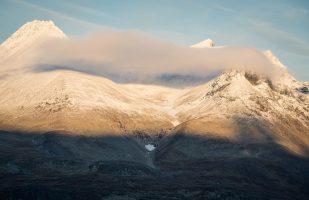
[0,71,172,134]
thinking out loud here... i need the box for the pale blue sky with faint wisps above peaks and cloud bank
[0,0,309,81]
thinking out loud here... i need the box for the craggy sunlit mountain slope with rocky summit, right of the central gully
[162,71,309,155]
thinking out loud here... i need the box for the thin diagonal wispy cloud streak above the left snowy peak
[13,0,105,29]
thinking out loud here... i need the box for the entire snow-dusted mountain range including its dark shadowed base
[0,21,309,199]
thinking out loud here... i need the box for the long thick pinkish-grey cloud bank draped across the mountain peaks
[25,31,279,83]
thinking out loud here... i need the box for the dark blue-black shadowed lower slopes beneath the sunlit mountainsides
[0,132,309,200]
